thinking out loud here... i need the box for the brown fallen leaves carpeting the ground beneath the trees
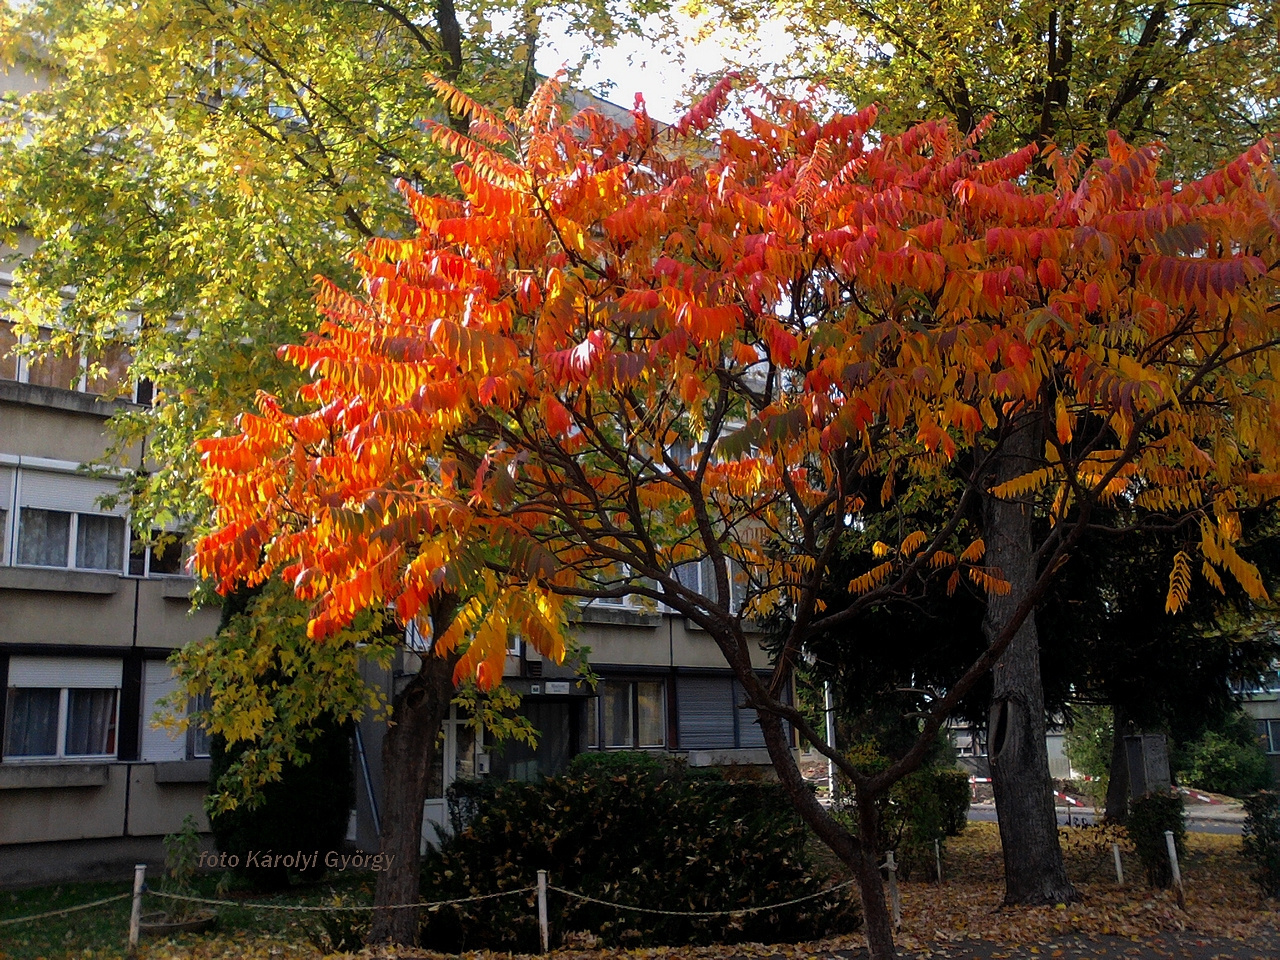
[102,823,1280,960]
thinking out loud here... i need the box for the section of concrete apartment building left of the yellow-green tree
[0,280,218,883]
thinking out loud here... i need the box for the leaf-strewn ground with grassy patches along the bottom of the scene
[0,823,1280,960]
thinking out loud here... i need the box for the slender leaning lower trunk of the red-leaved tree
[752,701,897,960]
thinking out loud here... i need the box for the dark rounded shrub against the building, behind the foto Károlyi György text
[209,722,356,890]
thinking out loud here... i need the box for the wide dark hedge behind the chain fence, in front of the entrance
[422,760,858,952]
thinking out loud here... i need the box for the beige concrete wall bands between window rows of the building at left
[0,380,218,884]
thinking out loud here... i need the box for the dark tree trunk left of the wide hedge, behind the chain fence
[367,655,457,946]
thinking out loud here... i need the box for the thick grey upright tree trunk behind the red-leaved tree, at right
[982,411,1075,904]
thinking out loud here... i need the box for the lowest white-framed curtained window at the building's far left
[4,657,120,759]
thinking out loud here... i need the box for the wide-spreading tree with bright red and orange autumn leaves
[197,83,1280,959]
